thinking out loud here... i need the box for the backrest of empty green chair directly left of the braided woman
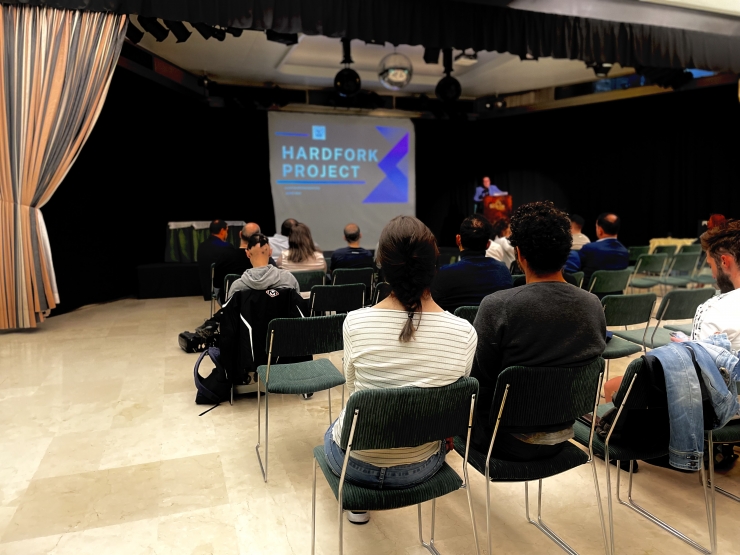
[265,314,347,357]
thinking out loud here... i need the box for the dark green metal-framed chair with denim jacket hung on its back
[573,357,716,555]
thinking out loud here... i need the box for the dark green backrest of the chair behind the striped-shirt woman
[340,378,480,450]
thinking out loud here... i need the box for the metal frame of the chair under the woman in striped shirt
[311,393,480,555]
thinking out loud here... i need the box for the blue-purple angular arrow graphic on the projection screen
[363,126,409,204]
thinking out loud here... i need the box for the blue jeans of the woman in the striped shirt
[324,424,445,489]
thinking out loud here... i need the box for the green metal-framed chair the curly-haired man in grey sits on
[455,358,608,554]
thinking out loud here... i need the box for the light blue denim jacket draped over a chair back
[649,334,740,470]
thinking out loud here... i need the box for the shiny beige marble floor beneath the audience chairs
[0,298,740,555]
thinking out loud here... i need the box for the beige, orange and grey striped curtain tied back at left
[0,5,127,329]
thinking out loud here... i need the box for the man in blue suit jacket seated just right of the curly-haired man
[564,213,629,288]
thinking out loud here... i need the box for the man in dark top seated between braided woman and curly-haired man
[431,214,511,313]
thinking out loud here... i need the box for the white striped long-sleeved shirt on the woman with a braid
[332,308,478,467]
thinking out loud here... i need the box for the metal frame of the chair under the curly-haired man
[485,372,609,555]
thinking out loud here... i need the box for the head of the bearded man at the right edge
[700,220,740,293]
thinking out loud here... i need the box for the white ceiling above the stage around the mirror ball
[139,22,632,98]
